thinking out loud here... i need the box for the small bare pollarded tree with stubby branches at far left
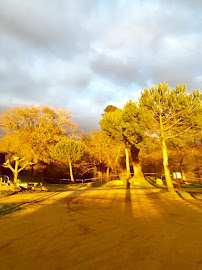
[3,157,34,186]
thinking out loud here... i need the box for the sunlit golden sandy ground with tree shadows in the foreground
[0,188,202,270]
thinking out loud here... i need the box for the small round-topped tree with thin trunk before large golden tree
[51,139,86,182]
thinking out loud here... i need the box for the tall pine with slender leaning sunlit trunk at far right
[140,83,201,192]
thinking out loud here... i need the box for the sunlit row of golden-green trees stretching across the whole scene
[0,83,202,191]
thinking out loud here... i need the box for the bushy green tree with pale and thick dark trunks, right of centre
[100,100,146,184]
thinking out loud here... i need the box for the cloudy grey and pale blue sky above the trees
[0,0,202,132]
